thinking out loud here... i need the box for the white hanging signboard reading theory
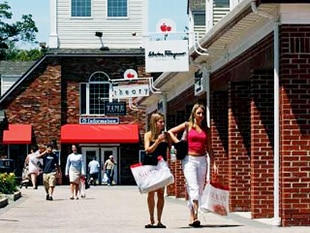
[112,84,150,99]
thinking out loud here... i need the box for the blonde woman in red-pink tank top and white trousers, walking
[169,103,213,227]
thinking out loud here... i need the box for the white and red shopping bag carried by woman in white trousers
[199,182,229,216]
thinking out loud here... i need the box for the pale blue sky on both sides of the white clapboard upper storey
[6,0,187,48]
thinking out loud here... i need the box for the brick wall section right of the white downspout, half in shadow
[280,25,310,226]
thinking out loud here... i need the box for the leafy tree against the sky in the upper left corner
[0,2,38,60]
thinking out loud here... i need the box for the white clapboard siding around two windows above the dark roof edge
[57,0,144,48]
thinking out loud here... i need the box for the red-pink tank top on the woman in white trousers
[187,128,207,155]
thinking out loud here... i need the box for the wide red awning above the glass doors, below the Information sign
[61,124,139,143]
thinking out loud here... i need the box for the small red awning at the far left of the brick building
[3,124,32,144]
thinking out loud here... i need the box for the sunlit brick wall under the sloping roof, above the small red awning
[6,65,61,144]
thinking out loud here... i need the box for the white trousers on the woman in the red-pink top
[182,155,207,208]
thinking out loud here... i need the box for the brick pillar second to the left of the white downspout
[228,82,251,211]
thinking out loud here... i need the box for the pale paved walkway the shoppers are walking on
[0,186,310,233]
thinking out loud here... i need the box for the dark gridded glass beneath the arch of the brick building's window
[89,83,110,114]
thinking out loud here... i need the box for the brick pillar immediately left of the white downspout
[251,70,274,218]
